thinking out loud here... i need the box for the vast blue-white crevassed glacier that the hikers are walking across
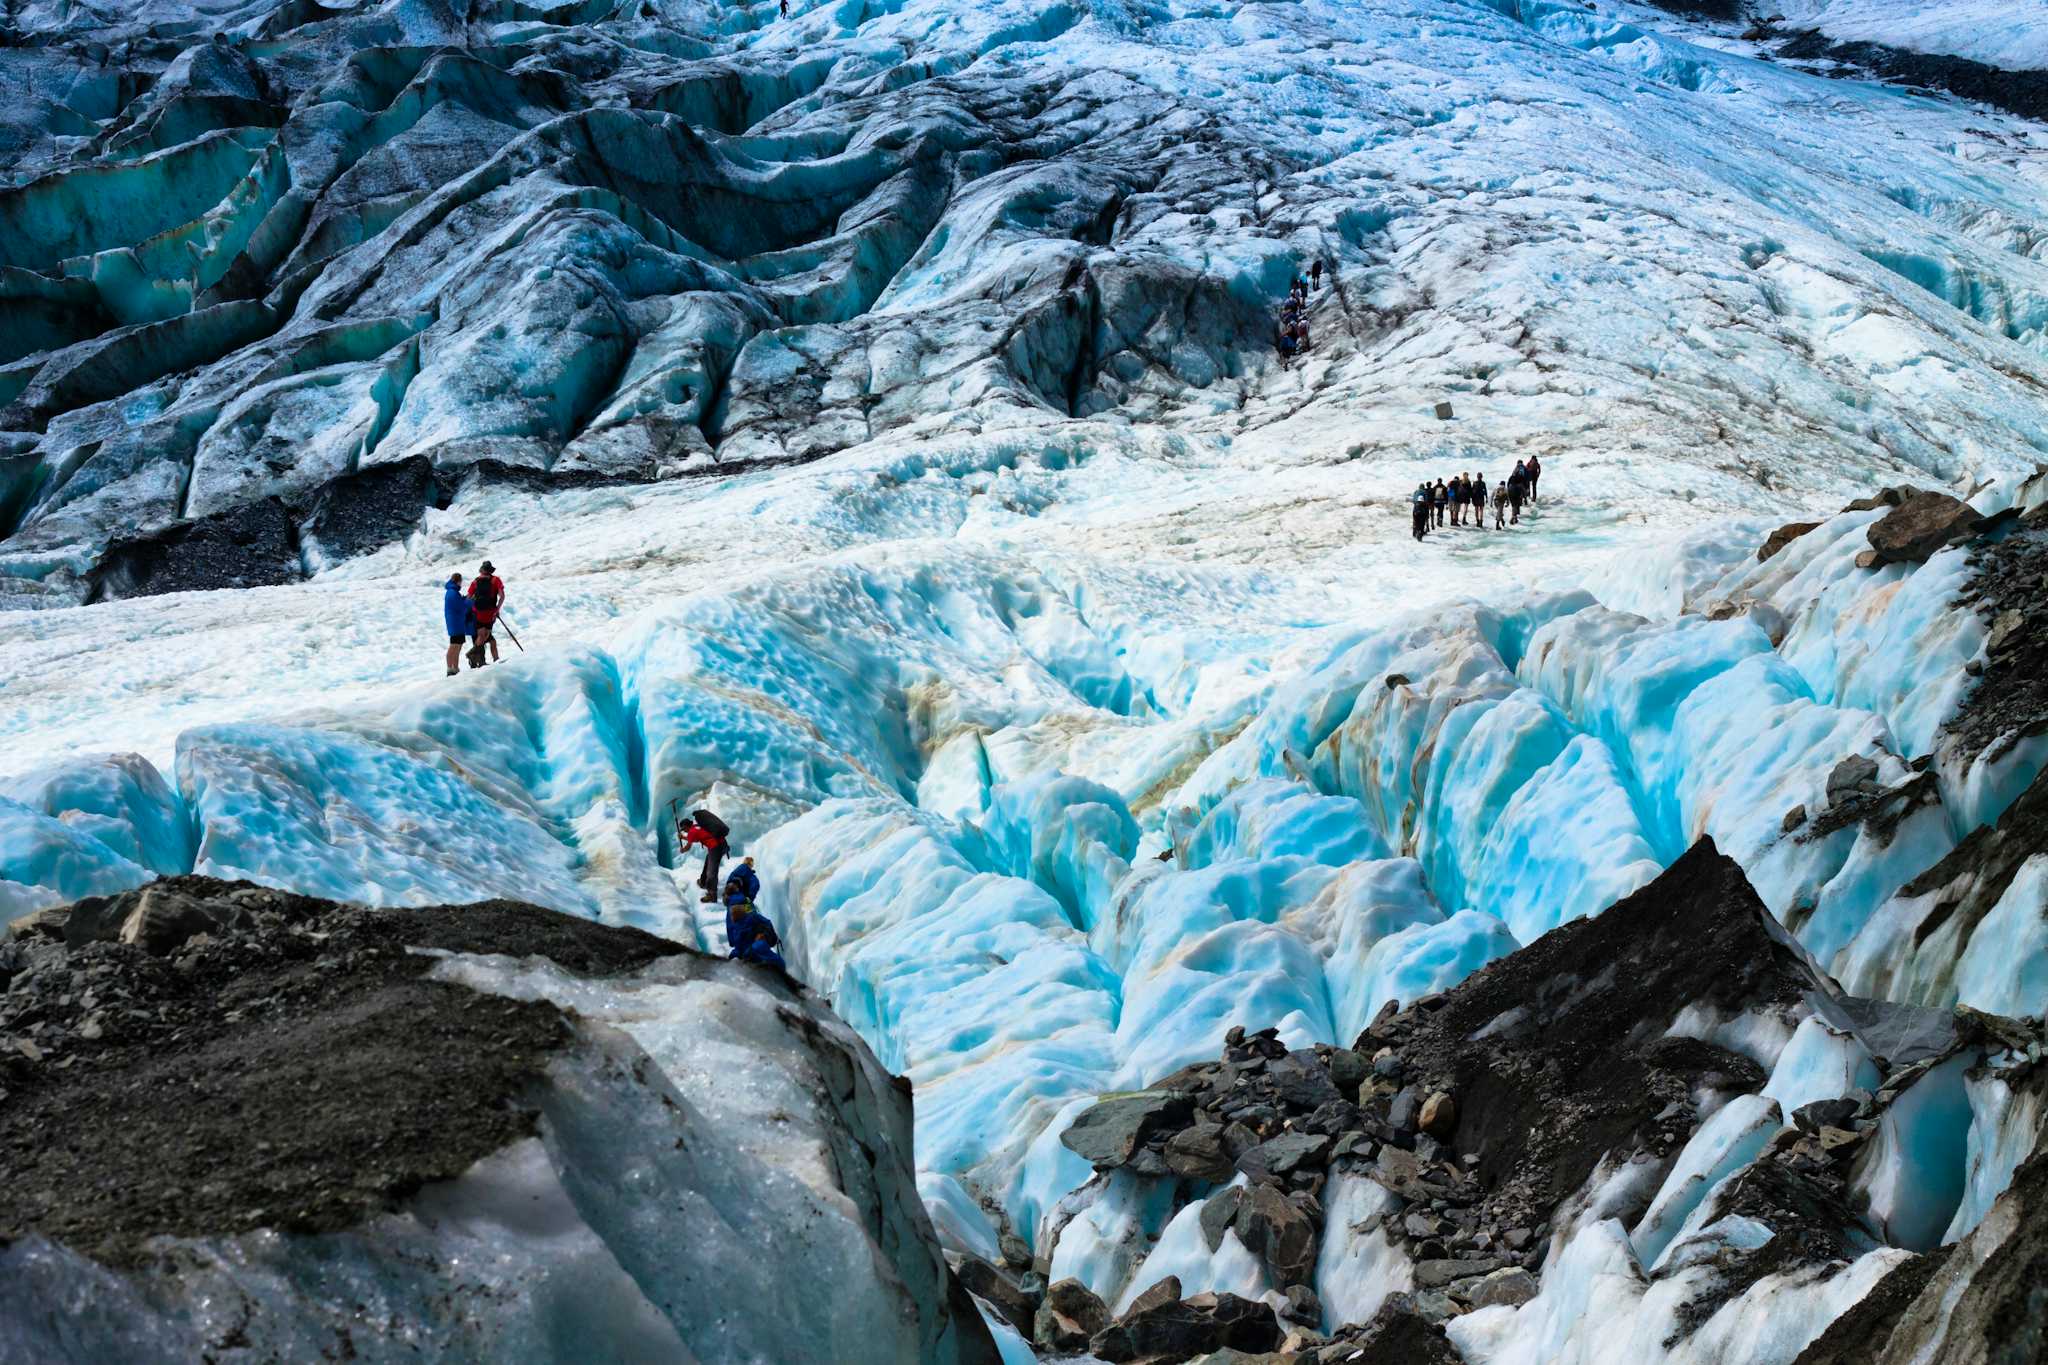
[0,0,2048,1365]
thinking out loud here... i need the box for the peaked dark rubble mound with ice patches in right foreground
[961,841,2048,1365]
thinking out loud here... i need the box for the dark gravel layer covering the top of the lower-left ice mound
[0,878,682,1265]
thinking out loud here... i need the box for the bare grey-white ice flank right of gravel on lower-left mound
[436,956,981,1365]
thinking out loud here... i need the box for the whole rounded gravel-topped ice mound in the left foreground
[0,878,995,1365]
